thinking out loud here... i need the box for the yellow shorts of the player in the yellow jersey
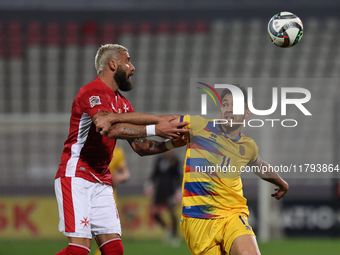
[180,213,255,255]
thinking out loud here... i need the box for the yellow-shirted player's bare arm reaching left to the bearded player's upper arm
[93,112,180,135]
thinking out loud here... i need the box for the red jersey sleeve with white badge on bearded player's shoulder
[79,89,113,118]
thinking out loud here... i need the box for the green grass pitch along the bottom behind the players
[0,239,340,255]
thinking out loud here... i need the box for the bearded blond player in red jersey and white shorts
[55,44,189,255]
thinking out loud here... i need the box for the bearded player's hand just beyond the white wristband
[155,116,190,139]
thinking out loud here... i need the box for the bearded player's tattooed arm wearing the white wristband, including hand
[92,111,190,140]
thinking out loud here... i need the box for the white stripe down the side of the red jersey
[65,113,92,177]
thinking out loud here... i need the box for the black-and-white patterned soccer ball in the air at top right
[268,12,303,48]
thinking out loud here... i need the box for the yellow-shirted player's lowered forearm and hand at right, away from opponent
[248,156,289,200]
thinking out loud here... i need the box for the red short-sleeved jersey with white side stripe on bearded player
[56,78,134,185]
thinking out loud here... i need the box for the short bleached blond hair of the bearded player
[94,44,128,74]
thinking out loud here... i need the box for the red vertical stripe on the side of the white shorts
[60,177,76,233]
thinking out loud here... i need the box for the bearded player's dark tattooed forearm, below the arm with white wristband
[128,135,187,156]
